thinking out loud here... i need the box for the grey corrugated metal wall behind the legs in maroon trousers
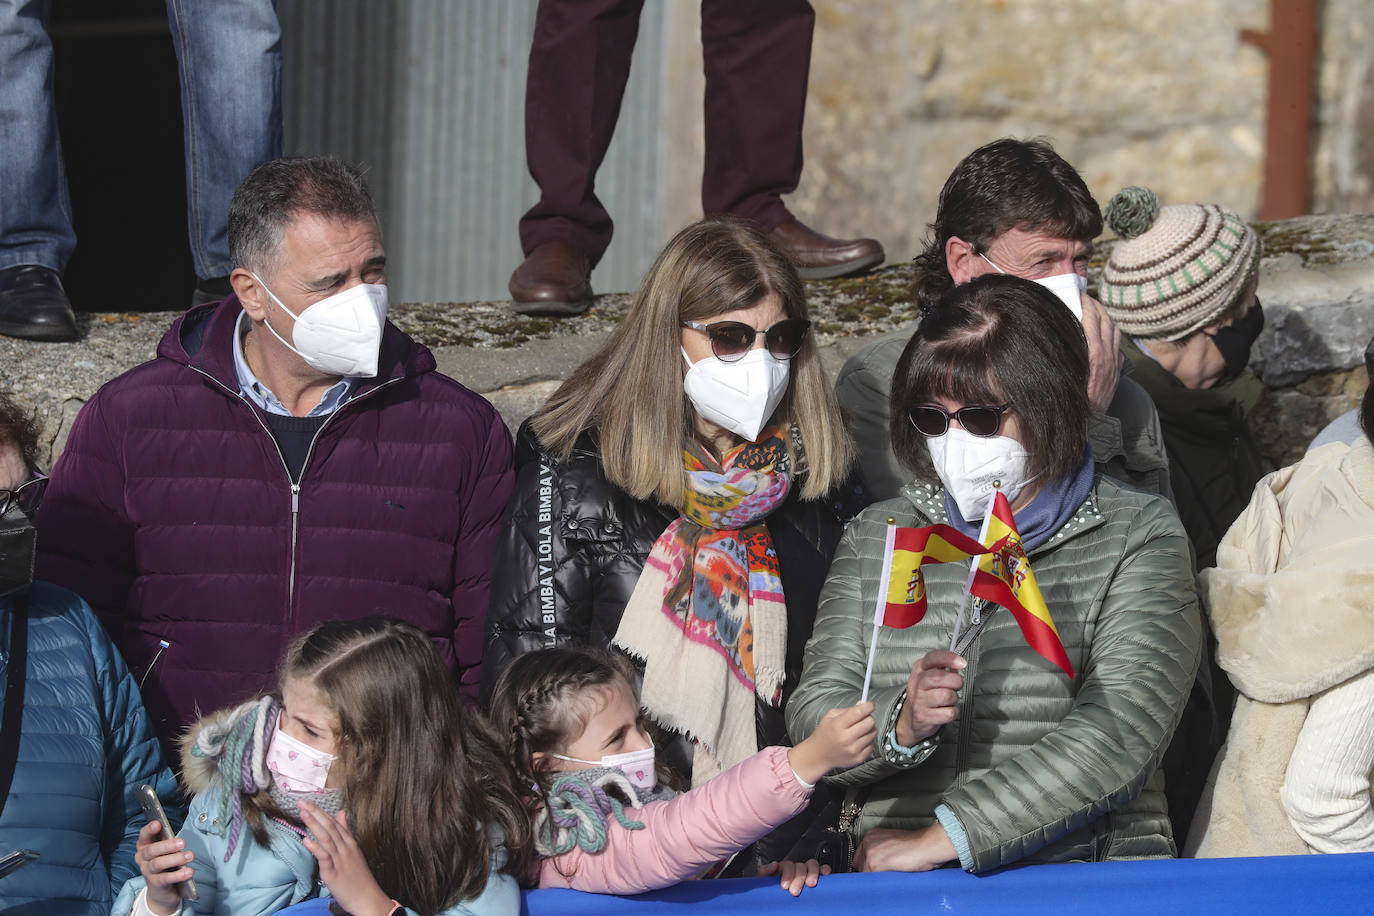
[278,0,665,302]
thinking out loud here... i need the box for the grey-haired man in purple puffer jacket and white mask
[38,158,511,746]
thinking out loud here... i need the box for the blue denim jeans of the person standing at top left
[0,0,282,277]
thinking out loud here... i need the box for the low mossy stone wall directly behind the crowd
[0,214,1374,477]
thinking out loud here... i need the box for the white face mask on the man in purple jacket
[253,273,386,378]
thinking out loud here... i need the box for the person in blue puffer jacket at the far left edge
[0,393,179,916]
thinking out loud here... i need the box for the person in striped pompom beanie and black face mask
[1099,188,1272,569]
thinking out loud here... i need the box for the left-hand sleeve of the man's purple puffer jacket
[36,390,135,642]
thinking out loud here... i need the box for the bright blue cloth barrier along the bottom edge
[283,853,1374,916]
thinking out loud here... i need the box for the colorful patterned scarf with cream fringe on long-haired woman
[613,427,791,786]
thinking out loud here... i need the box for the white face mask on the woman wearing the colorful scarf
[683,347,791,442]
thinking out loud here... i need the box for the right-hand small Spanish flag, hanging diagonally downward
[969,492,1073,680]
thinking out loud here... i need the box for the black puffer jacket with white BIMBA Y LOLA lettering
[482,422,867,777]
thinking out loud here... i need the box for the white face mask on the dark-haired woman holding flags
[926,426,1035,522]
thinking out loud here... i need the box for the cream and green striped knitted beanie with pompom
[1099,188,1260,341]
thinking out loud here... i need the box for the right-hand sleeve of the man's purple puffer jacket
[453,411,515,698]
